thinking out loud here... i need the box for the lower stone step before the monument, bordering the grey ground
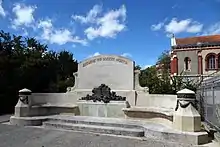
[43,121,144,137]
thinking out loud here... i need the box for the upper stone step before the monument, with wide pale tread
[47,116,143,129]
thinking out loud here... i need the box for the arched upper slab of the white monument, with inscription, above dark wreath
[67,55,148,105]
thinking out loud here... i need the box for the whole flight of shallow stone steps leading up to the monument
[43,116,144,137]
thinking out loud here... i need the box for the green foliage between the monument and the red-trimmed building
[140,51,199,94]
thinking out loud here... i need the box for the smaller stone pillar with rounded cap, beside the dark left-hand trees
[15,88,32,117]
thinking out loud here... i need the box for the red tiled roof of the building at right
[176,35,220,45]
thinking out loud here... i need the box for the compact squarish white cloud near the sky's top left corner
[12,3,37,29]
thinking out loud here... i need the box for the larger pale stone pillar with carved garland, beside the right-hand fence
[173,89,201,132]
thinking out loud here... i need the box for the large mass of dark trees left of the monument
[0,31,78,113]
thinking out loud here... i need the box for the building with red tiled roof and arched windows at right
[170,35,220,78]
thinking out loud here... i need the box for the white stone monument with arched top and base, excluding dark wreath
[68,55,148,117]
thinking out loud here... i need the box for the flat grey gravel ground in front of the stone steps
[0,124,201,147]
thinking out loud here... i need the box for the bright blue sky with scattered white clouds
[0,0,220,67]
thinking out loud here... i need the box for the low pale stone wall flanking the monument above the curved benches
[31,89,177,109]
